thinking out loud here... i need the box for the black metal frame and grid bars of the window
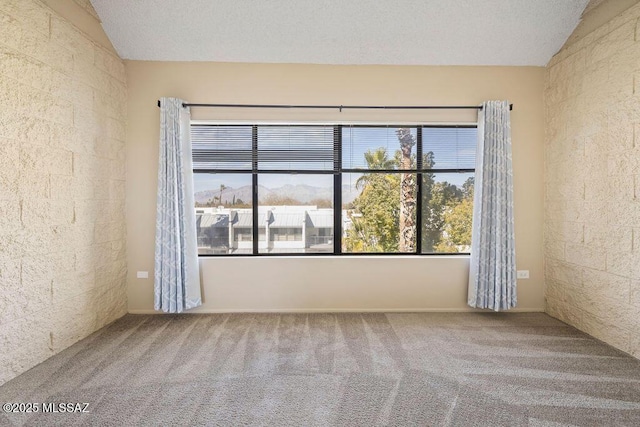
[190,120,478,258]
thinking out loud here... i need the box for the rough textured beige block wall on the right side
[544,1,640,357]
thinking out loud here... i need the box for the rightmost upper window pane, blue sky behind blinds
[422,127,477,170]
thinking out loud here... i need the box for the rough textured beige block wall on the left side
[0,0,126,384]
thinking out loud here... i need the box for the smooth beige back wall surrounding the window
[125,61,544,312]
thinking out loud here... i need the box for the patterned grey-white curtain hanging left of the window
[154,98,202,313]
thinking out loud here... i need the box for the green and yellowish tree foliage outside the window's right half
[344,145,473,252]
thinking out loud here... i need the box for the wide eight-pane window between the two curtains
[191,124,476,255]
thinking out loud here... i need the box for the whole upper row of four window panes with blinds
[191,125,477,172]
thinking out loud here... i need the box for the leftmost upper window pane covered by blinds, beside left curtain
[191,125,253,171]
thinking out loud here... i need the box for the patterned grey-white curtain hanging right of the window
[468,101,517,311]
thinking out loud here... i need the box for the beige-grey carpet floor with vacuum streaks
[0,313,640,427]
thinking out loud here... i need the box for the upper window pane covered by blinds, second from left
[257,126,337,171]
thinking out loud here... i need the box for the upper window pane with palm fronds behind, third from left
[342,126,418,170]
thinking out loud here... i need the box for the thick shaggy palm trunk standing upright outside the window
[396,128,416,252]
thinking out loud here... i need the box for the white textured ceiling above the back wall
[91,0,588,66]
